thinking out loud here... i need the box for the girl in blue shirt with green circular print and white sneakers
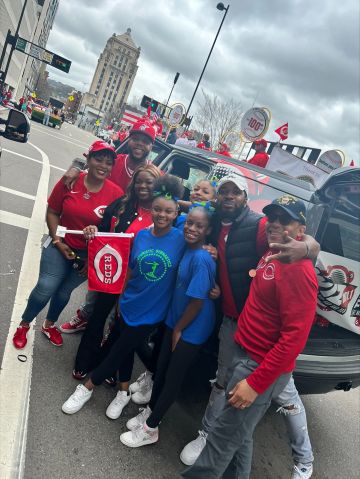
[62,175,185,419]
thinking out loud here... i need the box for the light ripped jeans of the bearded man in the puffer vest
[202,316,314,464]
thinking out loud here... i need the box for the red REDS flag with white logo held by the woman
[88,235,131,294]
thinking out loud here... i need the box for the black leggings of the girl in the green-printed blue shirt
[90,316,157,386]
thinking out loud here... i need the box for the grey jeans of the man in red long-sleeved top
[181,346,290,479]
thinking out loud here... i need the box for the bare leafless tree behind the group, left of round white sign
[194,90,243,148]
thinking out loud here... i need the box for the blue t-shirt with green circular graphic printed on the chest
[119,228,185,326]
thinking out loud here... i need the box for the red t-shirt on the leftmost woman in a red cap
[48,174,123,249]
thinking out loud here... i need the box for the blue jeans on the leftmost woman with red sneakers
[22,244,87,323]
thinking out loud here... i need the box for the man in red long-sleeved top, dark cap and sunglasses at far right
[181,195,317,479]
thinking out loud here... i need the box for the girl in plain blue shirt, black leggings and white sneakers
[120,206,216,447]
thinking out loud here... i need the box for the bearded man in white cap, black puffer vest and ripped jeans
[180,173,319,479]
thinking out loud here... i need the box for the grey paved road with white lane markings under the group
[0,123,360,479]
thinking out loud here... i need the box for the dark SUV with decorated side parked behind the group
[117,139,360,394]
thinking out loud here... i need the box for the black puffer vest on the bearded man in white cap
[211,206,262,314]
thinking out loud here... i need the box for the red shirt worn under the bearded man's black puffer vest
[218,218,269,318]
